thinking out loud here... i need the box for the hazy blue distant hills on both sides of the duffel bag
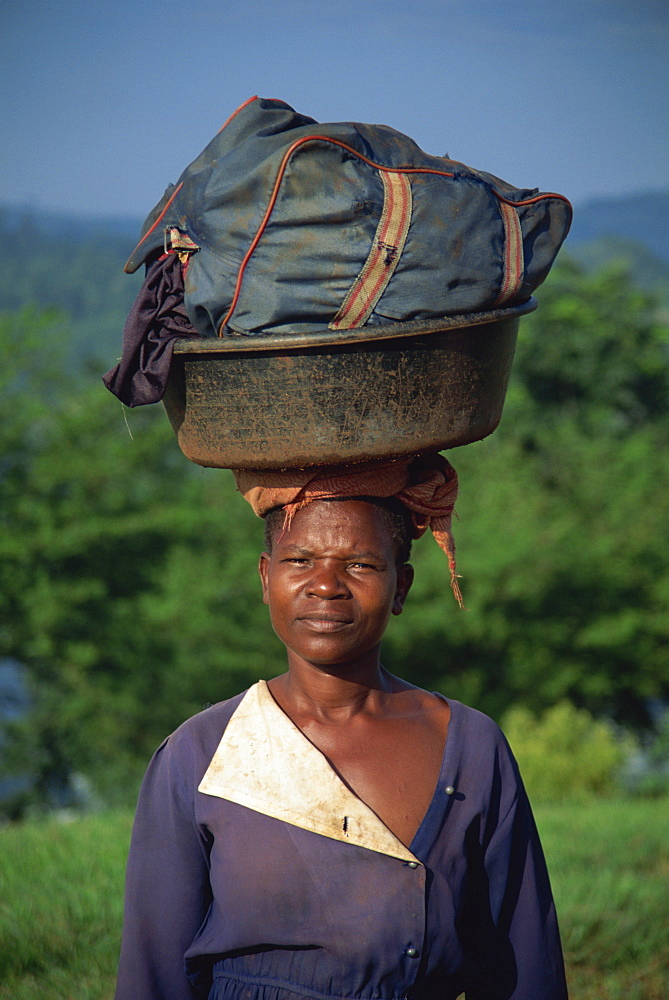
[0,191,669,371]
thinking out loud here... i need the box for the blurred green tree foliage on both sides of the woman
[0,254,669,816]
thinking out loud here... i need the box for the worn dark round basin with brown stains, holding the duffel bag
[164,299,536,469]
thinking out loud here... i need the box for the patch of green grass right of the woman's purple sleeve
[536,798,669,1000]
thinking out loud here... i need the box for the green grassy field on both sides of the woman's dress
[0,799,669,1000]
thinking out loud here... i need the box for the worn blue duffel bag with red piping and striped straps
[126,97,571,337]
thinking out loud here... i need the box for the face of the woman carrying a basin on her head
[259,500,413,666]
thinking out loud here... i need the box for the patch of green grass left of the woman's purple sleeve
[0,813,132,1000]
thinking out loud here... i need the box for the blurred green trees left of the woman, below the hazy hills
[0,313,276,812]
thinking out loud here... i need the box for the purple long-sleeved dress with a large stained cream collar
[116,681,567,1000]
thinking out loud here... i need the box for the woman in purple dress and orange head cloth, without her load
[116,455,566,1000]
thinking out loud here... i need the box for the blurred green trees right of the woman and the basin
[380,261,669,726]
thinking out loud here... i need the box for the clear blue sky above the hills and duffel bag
[0,0,669,217]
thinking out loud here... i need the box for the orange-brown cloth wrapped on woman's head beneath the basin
[235,452,464,608]
